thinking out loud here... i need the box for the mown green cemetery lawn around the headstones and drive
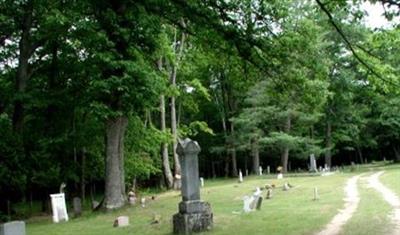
[27,165,400,235]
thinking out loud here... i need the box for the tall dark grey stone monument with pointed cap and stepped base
[173,138,213,234]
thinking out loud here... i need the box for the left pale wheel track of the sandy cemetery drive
[317,175,361,235]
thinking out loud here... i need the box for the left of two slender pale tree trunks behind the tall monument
[160,95,174,189]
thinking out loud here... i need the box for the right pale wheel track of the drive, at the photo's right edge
[368,171,400,235]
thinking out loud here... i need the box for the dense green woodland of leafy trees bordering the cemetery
[0,0,400,216]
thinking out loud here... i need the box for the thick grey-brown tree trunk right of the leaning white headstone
[103,116,128,209]
